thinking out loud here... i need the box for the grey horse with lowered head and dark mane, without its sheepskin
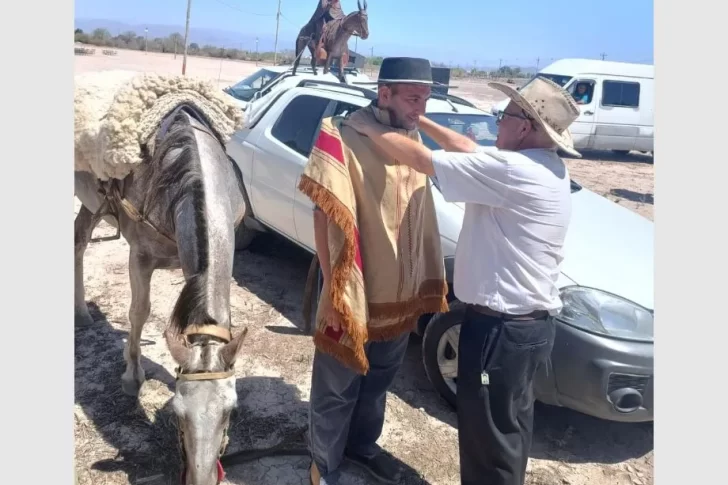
[74,109,246,485]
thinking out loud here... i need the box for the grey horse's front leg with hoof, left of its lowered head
[121,246,154,396]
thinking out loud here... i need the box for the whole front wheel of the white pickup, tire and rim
[422,301,465,407]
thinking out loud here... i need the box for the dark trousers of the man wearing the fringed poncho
[309,333,409,485]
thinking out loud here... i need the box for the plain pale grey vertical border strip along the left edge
[0,1,74,484]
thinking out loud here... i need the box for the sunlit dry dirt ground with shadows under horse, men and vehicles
[74,49,653,485]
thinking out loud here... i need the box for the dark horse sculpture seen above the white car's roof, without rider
[293,0,369,82]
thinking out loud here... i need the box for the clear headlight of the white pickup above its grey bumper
[557,286,654,342]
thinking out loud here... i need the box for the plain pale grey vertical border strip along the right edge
[656,0,728,485]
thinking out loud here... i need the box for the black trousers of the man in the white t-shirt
[457,307,555,485]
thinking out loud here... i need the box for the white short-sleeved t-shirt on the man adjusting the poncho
[432,147,571,315]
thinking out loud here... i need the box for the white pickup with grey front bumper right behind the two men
[227,79,654,421]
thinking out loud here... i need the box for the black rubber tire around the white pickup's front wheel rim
[422,301,465,408]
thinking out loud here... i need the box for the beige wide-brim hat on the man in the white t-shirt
[488,76,581,158]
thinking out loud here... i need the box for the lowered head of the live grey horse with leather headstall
[165,325,248,485]
